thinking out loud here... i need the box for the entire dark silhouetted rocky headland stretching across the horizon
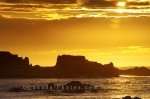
[0,51,150,78]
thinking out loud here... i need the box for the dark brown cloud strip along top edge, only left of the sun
[0,0,117,7]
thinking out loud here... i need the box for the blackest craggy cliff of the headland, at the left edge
[0,51,32,78]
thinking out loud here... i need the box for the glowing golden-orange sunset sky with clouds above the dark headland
[0,0,150,67]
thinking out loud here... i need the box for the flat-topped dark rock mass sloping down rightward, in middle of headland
[54,55,119,78]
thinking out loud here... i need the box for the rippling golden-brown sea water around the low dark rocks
[0,76,150,99]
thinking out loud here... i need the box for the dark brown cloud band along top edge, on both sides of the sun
[0,0,150,7]
